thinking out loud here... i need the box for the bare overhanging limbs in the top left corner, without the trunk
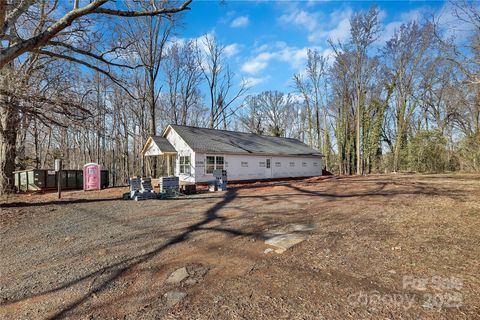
[0,0,192,69]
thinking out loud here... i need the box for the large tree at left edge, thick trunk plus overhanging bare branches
[0,0,191,192]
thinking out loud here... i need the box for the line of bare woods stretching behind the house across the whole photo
[0,0,480,191]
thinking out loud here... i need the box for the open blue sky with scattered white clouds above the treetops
[177,0,454,93]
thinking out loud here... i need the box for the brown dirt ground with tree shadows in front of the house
[0,175,480,319]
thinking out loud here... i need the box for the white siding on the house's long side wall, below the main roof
[195,153,323,182]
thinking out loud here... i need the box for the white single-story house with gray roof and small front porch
[142,125,323,183]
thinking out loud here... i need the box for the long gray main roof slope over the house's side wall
[162,125,321,156]
